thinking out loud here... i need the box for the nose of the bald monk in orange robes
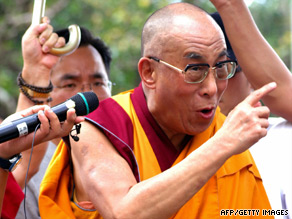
[200,68,218,97]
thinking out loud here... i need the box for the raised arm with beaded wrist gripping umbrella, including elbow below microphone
[13,17,65,188]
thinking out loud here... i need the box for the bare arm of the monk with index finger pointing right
[71,84,275,219]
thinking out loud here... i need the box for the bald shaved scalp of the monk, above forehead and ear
[141,3,221,56]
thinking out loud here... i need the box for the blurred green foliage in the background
[0,0,292,118]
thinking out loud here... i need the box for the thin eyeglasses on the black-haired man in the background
[54,80,115,94]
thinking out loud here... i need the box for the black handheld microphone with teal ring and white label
[0,91,99,143]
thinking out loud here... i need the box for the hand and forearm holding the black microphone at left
[0,105,84,215]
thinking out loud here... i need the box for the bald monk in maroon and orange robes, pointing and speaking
[39,0,288,219]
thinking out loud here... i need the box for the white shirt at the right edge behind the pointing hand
[250,117,292,219]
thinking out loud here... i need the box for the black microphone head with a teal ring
[70,91,99,116]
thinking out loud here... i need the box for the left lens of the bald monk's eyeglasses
[185,65,209,83]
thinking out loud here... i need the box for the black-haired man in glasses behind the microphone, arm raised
[14,18,112,219]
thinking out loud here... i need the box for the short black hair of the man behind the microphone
[56,27,112,76]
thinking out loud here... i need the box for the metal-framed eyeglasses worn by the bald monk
[149,57,237,84]
